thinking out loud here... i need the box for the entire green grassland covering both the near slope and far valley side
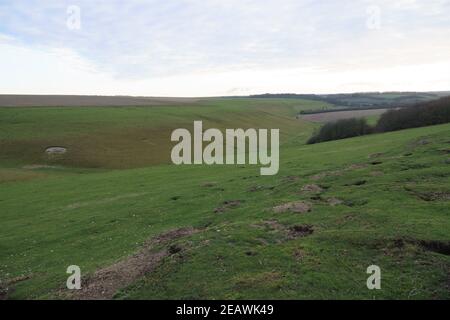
[0,99,450,299]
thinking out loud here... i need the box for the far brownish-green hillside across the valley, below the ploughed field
[0,99,323,169]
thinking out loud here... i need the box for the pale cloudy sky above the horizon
[0,0,450,97]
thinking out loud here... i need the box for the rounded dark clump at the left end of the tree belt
[308,119,372,144]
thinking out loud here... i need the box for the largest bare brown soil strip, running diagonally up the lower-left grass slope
[72,227,197,300]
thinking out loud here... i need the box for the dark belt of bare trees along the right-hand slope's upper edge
[308,97,450,144]
